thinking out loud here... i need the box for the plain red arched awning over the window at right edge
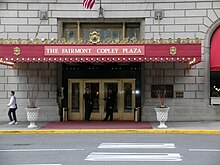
[210,27,220,71]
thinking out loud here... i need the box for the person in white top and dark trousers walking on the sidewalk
[8,91,17,125]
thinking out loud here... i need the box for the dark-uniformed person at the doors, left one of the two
[83,87,93,121]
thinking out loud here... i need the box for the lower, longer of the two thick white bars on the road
[85,152,182,162]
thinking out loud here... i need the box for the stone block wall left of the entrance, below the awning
[0,63,60,121]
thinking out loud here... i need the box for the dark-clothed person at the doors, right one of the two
[104,88,115,121]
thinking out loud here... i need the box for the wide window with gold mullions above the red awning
[63,23,140,41]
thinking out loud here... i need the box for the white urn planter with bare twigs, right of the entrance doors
[154,86,170,128]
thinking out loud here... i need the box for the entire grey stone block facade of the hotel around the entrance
[0,0,220,121]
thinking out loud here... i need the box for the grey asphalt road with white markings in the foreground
[0,134,220,165]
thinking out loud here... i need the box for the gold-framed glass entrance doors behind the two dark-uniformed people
[68,79,135,120]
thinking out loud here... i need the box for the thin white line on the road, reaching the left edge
[0,148,84,152]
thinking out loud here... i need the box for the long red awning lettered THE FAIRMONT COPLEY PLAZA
[0,43,201,64]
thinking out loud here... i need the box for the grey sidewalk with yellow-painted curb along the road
[0,121,220,134]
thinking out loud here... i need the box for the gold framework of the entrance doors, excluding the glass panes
[68,79,135,120]
